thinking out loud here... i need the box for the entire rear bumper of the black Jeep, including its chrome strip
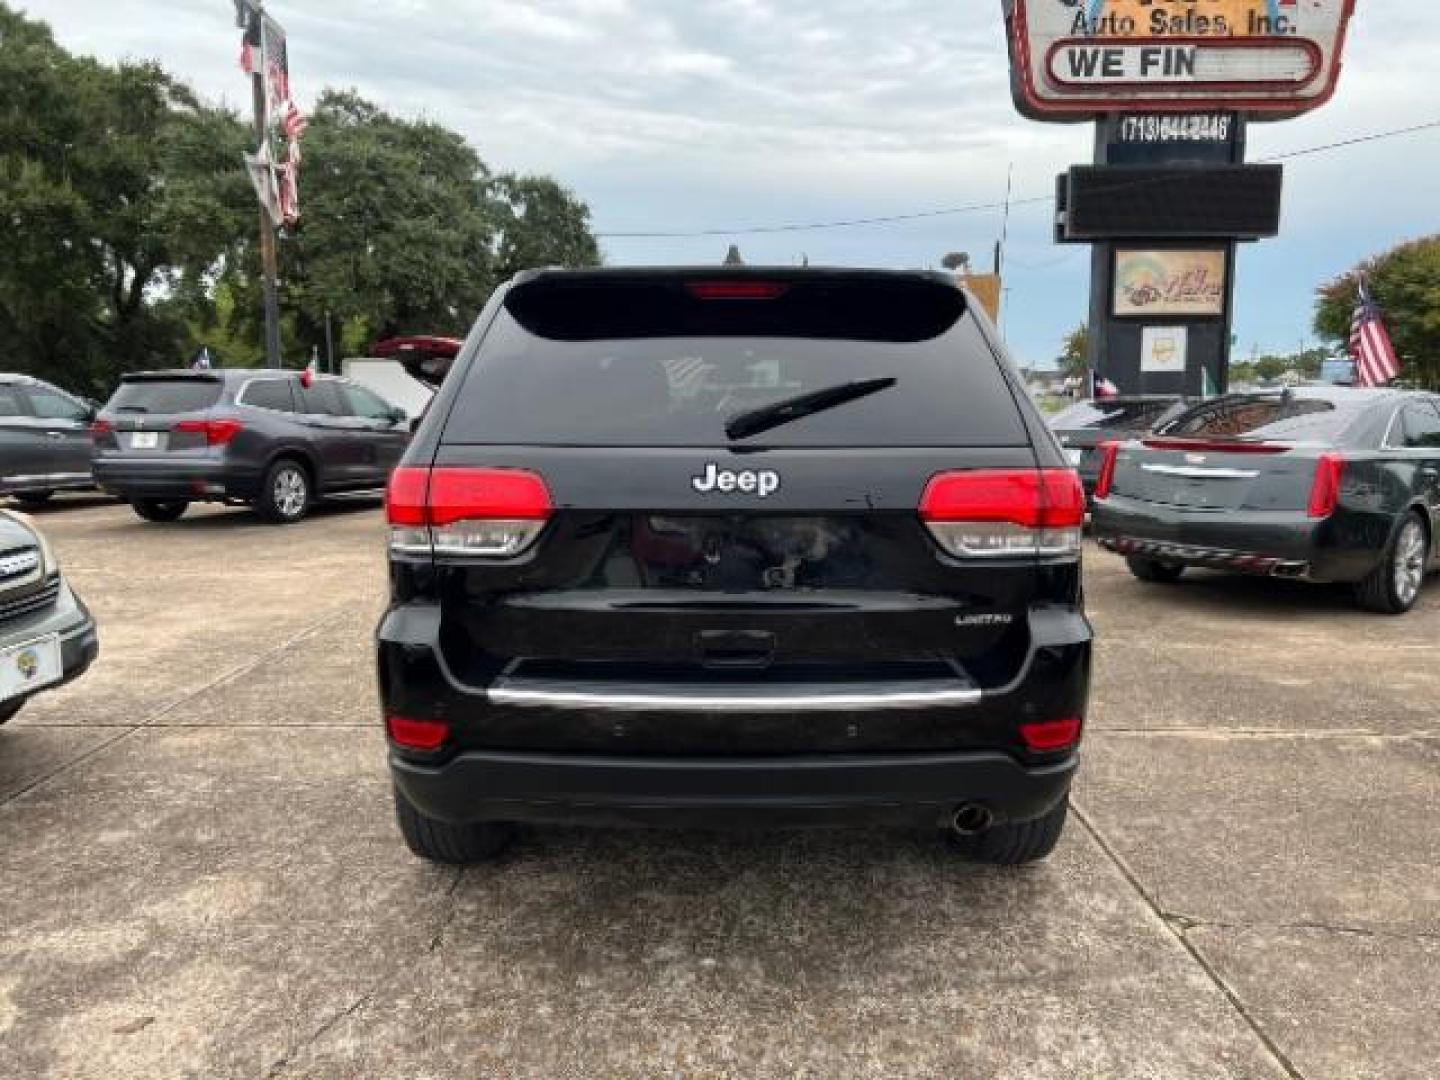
[377,603,1092,825]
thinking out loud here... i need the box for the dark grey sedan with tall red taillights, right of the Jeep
[1093,387,1440,615]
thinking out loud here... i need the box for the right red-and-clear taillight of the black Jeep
[920,469,1084,559]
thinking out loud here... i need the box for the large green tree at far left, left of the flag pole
[0,4,248,393]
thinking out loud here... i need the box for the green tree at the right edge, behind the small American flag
[1315,235,1440,387]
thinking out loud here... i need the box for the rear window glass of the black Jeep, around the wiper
[445,311,1028,446]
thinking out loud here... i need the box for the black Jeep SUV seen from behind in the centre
[377,269,1092,863]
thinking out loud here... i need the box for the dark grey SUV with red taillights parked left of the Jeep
[92,370,410,524]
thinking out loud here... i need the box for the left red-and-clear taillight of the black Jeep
[386,467,554,559]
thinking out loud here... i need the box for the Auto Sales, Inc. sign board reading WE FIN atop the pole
[1004,0,1355,120]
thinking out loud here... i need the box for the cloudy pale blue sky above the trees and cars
[22,0,1440,364]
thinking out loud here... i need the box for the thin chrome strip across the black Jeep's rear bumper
[487,684,985,713]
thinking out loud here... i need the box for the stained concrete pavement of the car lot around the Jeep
[0,498,1440,1080]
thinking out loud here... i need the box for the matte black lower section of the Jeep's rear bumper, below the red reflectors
[390,750,1077,827]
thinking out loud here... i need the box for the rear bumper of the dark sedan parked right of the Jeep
[1092,495,1380,582]
